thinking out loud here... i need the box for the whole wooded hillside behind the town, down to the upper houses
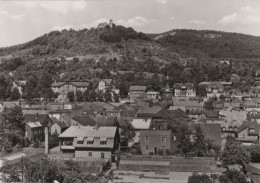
[0,25,260,98]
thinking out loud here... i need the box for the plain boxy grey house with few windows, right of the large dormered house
[140,130,173,155]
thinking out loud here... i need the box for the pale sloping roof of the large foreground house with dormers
[59,126,117,138]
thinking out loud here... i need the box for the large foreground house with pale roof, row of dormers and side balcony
[59,126,119,161]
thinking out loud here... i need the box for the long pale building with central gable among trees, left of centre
[51,81,89,94]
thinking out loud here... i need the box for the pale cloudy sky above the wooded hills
[0,0,260,47]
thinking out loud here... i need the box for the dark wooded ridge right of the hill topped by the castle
[151,30,260,59]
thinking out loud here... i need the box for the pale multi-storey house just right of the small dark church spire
[173,83,196,97]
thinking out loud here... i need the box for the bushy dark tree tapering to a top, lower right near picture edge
[222,136,251,166]
